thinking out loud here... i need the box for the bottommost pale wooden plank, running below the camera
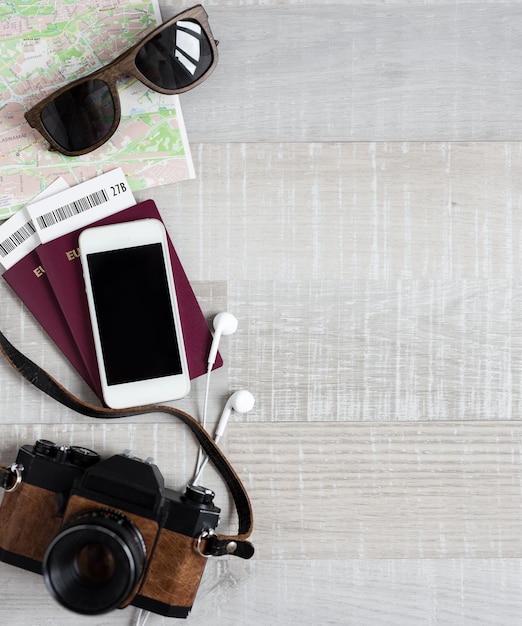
[4,558,522,626]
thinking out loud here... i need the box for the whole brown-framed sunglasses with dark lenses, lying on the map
[25,5,218,156]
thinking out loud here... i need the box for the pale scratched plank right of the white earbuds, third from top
[224,280,522,426]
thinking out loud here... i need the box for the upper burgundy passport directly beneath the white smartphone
[34,200,223,397]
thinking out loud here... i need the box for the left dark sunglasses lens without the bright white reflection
[40,80,115,152]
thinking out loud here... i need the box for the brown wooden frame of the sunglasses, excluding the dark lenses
[25,5,215,156]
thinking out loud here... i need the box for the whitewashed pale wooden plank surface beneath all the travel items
[0,0,522,626]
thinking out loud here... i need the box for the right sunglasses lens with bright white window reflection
[135,19,214,90]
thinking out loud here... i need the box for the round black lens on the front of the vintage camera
[43,509,146,615]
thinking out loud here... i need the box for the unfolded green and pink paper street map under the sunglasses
[0,0,194,220]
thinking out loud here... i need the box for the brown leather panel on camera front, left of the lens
[0,482,62,563]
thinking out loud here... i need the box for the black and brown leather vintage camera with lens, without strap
[0,439,220,617]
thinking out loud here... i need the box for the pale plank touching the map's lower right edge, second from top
[145,143,522,281]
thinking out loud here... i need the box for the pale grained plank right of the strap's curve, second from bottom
[228,422,522,561]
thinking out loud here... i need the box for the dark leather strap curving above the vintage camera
[0,331,254,559]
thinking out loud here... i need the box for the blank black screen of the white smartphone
[87,243,182,385]
